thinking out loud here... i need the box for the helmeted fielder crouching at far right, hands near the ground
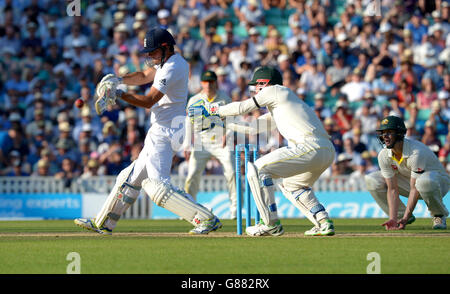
[365,116,450,230]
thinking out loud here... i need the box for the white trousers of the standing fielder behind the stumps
[184,145,237,217]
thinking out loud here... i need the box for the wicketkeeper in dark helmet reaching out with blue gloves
[188,67,335,236]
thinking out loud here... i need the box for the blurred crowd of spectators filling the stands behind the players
[0,0,450,187]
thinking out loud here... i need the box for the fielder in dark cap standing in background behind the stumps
[184,70,237,219]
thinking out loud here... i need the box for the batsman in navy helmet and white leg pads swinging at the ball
[75,27,222,234]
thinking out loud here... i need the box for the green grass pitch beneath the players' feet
[0,219,450,274]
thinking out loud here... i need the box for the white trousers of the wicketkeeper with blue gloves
[255,138,335,192]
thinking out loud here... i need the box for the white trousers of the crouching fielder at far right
[364,171,450,217]
